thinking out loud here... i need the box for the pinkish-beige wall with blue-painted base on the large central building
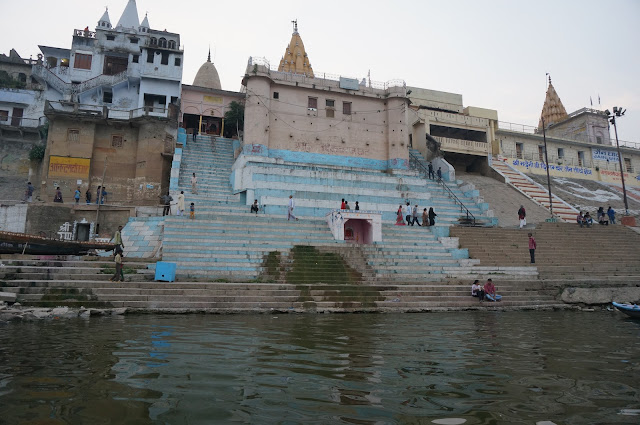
[244,68,409,169]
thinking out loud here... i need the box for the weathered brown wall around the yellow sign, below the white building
[41,117,177,205]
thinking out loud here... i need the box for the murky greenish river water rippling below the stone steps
[0,312,640,425]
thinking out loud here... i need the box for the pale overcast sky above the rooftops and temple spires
[0,0,640,144]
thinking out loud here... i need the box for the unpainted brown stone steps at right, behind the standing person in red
[451,223,640,293]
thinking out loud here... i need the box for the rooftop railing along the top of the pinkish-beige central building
[247,56,407,91]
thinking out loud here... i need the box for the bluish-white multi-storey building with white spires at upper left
[33,0,184,118]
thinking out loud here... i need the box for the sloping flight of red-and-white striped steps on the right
[491,158,578,223]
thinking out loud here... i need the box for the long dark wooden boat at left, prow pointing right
[0,232,116,255]
